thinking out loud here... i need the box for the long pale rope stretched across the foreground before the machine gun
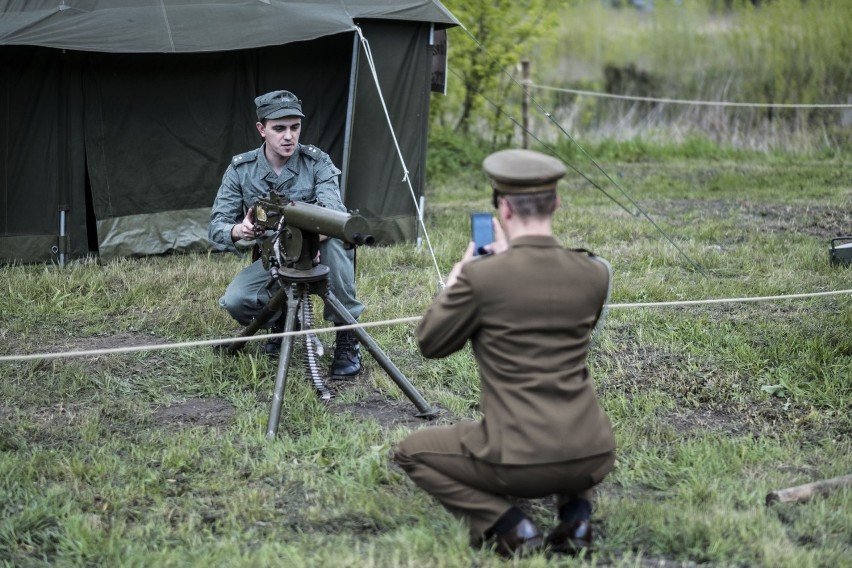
[0,289,852,363]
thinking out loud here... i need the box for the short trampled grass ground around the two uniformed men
[0,155,852,568]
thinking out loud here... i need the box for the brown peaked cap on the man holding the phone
[482,150,566,194]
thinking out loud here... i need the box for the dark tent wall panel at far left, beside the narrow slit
[0,46,89,263]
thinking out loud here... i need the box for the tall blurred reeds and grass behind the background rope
[516,0,852,152]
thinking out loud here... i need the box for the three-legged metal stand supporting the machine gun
[229,264,437,439]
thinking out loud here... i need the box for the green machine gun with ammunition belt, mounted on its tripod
[228,194,436,439]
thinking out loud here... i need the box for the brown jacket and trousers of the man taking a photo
[395,236,615,540]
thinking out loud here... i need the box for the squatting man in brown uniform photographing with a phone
[394,150,615,555]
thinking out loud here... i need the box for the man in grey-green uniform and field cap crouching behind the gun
[209,91,364,379]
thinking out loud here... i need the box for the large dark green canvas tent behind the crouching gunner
[0,0,458,263]
